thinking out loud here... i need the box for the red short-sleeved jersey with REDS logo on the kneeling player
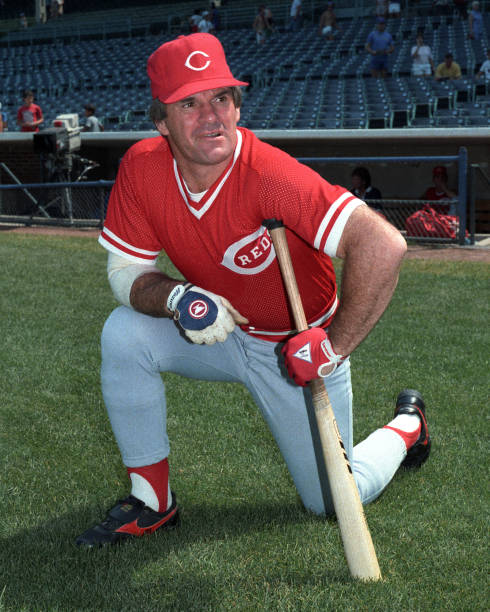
[99,128,363,341]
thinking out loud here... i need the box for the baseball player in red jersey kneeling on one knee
[77,34,430,547]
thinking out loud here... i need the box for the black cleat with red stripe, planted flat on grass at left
[75,493,179,548]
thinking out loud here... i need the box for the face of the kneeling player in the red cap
[156,87,240,166]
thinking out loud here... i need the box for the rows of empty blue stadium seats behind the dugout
[0,1,490,130]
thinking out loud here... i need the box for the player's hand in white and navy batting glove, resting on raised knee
[167,285,248,344]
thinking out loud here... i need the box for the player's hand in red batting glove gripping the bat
[281,327,345,387]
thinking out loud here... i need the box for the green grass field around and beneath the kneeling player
[0,232,490,612]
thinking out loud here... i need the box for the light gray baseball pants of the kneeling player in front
[101,306,406,514]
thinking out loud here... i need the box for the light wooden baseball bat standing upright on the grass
[264,219,381,580]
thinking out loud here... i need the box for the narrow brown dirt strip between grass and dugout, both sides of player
[0,225,490,263]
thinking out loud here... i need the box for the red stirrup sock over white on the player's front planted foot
[126,458,172,512]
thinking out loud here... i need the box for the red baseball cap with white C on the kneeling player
[147,33,248,104]
